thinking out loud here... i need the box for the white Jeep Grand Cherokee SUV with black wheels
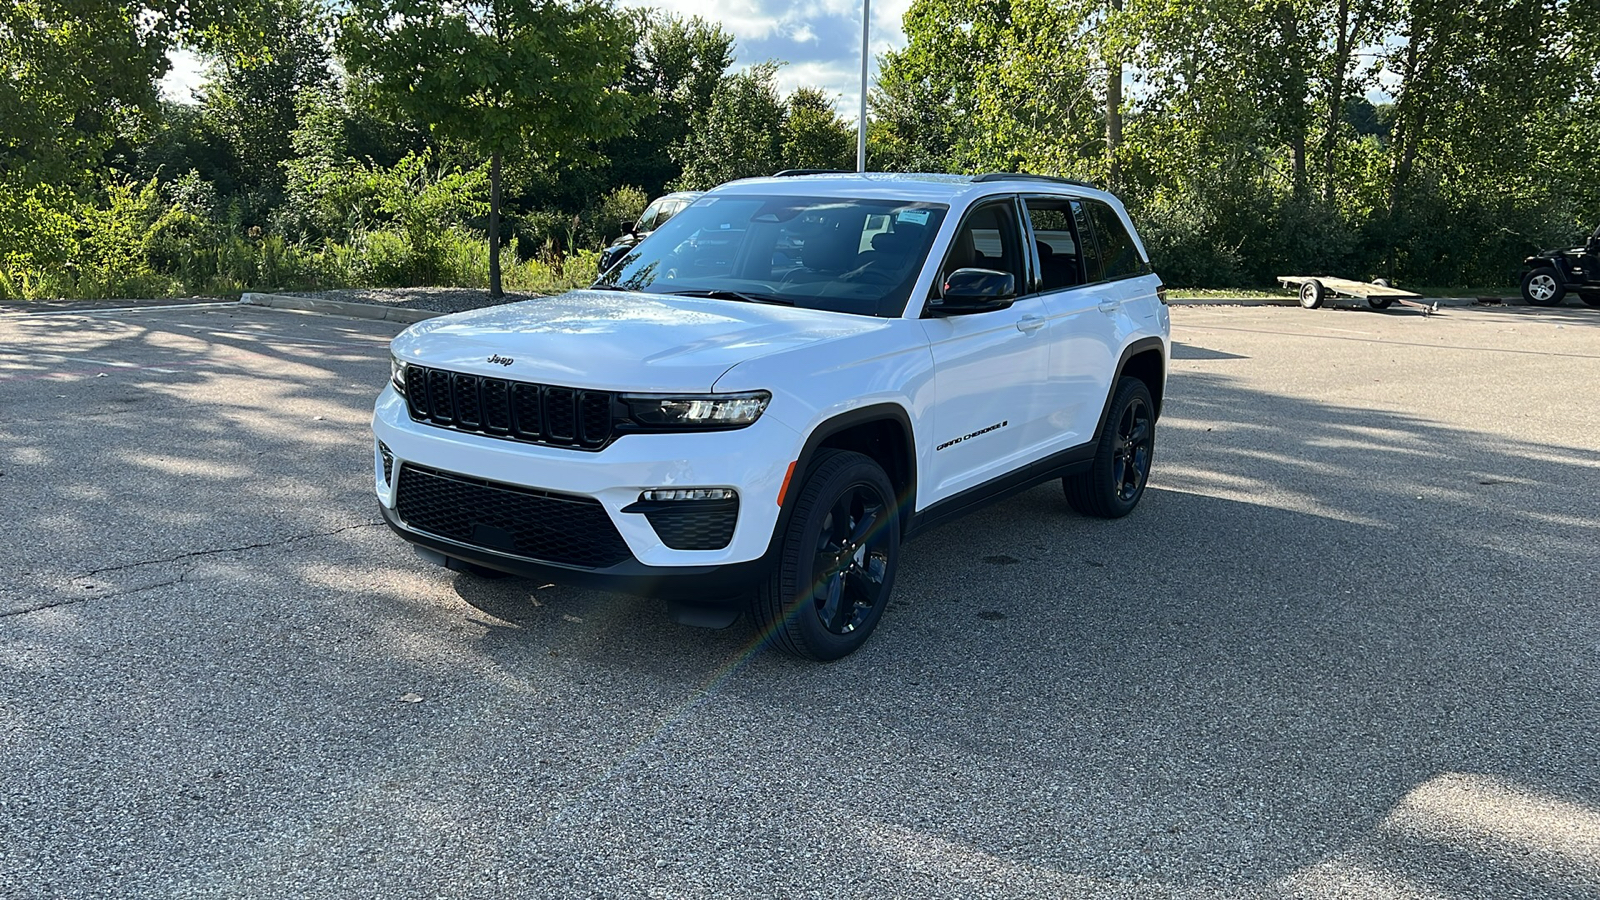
[373,173,1171,660]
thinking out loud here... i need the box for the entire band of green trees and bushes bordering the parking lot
[0,0,1600,296]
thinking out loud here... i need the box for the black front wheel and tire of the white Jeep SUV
[750,450,901,661]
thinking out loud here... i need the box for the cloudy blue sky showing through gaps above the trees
[162,0,910,125]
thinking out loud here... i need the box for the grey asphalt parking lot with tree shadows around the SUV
[0,297,1600,898]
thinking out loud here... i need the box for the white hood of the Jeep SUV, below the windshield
[392,290,888,392]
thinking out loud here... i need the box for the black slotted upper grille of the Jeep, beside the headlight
[405,365,626,450]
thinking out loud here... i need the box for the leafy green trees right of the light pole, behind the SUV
[870,0,1600,287]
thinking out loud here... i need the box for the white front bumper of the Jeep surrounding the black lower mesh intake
[373,388,802,596]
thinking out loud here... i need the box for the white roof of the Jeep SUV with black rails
[707,171,1122,207]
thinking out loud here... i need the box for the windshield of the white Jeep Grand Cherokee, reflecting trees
[595,194,949,317]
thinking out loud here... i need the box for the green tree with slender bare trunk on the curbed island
[339,0,635,296]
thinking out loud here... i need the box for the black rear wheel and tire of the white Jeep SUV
[1061,376,1155,519]
